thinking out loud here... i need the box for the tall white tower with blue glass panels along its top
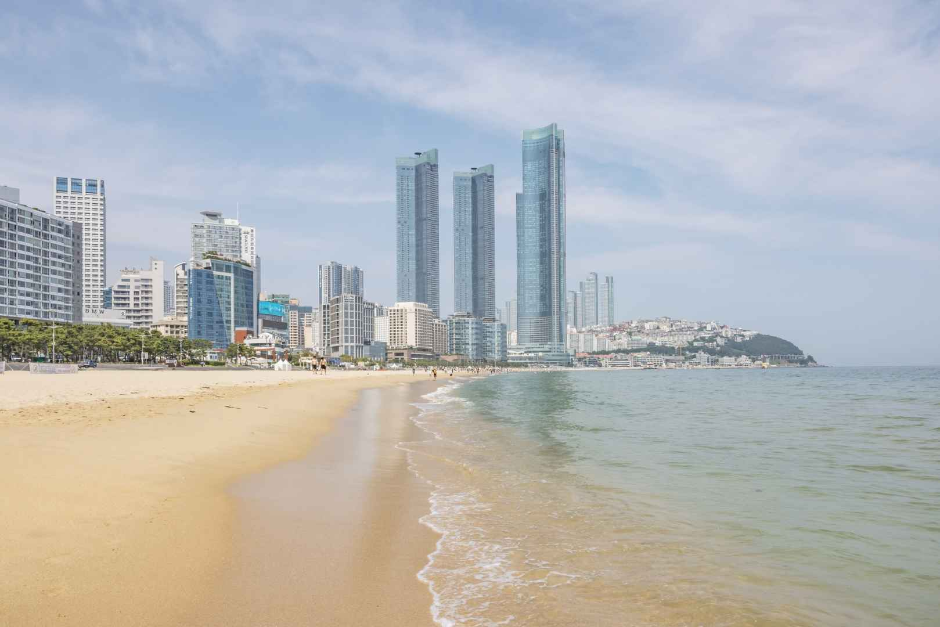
[53,176,107,309]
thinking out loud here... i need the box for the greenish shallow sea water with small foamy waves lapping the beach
[407,368,940,625]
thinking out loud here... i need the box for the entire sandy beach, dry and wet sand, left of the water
[0,371,436,625]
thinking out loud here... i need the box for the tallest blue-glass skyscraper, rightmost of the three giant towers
[510,124,570,364]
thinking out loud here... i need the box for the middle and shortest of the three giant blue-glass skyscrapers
[454,165,496,318]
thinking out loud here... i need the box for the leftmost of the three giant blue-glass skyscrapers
[395,148,441,318]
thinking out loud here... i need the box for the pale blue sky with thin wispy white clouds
[0,0,940,365]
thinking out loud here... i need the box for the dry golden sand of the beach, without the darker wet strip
[0,372,434,625]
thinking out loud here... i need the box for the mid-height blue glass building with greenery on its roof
[188,258,258,350]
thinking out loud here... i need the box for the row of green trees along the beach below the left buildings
[0,318,212,362]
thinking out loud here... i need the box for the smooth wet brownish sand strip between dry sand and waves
[184,382,438,626]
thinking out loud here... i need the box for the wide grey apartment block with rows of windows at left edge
[0,194,82,323]
